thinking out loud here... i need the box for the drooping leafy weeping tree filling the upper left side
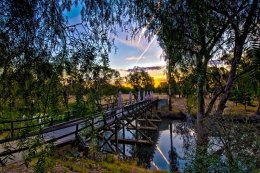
[0,0,118,167]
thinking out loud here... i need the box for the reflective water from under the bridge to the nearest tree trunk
[104,119,195,172]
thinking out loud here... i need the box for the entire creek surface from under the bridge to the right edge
[100,119,260,172]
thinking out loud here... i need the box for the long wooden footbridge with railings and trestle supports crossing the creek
[0,94,161,163]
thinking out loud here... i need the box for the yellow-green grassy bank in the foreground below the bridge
[0,146,165,173]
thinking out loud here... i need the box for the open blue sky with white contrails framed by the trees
[64,6,165,69]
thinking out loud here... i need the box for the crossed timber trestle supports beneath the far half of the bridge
[100,101,161,156]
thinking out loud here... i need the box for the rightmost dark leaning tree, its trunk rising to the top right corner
[211,0,260,116]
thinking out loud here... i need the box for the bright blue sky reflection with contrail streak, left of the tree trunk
[151,120,195,172]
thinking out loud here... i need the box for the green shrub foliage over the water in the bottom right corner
[185,118,260,173]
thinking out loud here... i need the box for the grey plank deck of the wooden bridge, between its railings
[0,100,159,161]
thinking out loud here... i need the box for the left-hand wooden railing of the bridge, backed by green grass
[0,98,148,144]
